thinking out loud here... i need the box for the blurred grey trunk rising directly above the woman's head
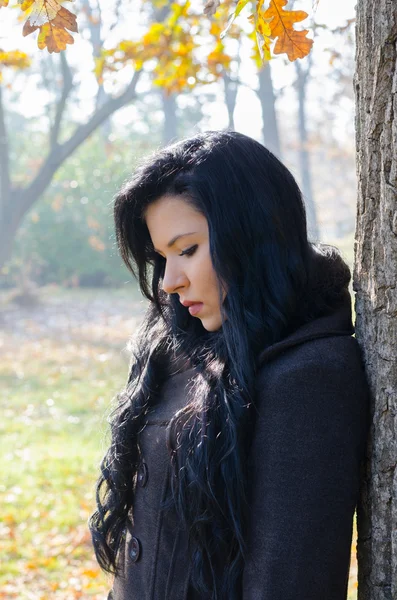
[257,61,282,160]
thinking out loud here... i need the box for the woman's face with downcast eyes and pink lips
[145,196,226,331]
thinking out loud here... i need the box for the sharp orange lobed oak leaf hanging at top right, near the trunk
[263,0,313,61]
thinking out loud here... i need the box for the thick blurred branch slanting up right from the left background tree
[18,71,142,212]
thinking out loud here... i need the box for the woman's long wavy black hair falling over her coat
[89,131,350,600]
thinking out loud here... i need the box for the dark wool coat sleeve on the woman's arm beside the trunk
[242,338,369,600]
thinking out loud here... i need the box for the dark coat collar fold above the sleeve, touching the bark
[258,293,355,366]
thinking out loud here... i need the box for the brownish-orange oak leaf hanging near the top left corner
[22,0,78,53]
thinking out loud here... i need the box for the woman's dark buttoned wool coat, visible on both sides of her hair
[109,302,369,600]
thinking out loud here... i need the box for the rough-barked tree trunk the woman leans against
[353,0,397,600]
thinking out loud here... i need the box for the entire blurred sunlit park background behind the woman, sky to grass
[0,0,357,600]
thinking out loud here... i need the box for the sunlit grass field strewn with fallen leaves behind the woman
[0,288,356,600]
